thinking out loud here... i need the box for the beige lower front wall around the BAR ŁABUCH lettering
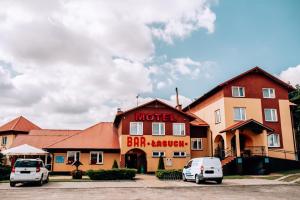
[120,135,191,172]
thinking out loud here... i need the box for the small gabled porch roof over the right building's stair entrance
[220,119,274,133]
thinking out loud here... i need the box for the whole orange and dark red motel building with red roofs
[0,67,298,173]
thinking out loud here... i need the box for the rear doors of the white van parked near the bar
[203,157,223,178]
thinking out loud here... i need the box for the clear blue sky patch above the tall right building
[153,0,300,98]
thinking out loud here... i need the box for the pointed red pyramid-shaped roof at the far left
[0,116,41,132]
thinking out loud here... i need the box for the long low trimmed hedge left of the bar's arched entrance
[86,169,137,180]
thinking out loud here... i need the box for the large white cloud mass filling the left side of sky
[0,0,215,128]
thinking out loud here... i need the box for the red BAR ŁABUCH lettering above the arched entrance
[127,136,188,147]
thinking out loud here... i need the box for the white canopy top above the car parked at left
[1,144,48,156]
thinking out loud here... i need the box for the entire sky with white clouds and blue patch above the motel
[0,0,300,129]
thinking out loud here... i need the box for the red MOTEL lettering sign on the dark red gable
[134,113,176,122]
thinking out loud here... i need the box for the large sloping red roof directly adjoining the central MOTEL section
[47,122,120,149]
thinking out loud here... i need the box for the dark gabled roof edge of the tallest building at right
[183,67,295,111]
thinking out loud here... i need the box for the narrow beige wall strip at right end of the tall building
[269,100,295,160]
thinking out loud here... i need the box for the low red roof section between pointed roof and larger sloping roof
[11,129,80,149]
